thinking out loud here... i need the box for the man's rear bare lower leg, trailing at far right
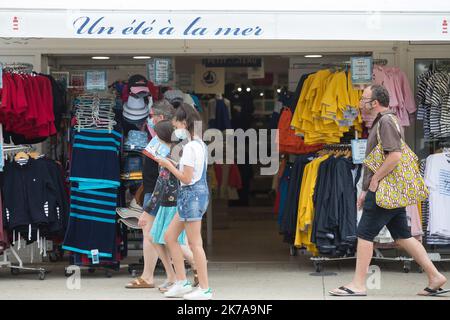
[396,238,447,294]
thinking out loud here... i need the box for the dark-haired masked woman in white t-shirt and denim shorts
[159,104,212,300]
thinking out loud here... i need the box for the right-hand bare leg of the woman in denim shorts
[185,221,209,289]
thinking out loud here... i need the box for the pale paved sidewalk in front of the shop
[0,257,450,300]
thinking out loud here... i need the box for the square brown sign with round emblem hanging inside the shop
[194,64,225,94]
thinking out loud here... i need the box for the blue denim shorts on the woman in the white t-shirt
[177,185,209,222]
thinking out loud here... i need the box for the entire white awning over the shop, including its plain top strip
[0,0,450,41]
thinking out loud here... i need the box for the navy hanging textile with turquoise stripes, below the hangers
[63,130,122,259]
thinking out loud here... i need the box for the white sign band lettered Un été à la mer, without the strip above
[0,9,450,40]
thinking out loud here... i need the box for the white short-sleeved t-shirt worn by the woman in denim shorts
[180,139,206,186]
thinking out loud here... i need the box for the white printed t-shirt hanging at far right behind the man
[425,153,450,237]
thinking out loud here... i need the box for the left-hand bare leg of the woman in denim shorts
[164,213,186,281]
